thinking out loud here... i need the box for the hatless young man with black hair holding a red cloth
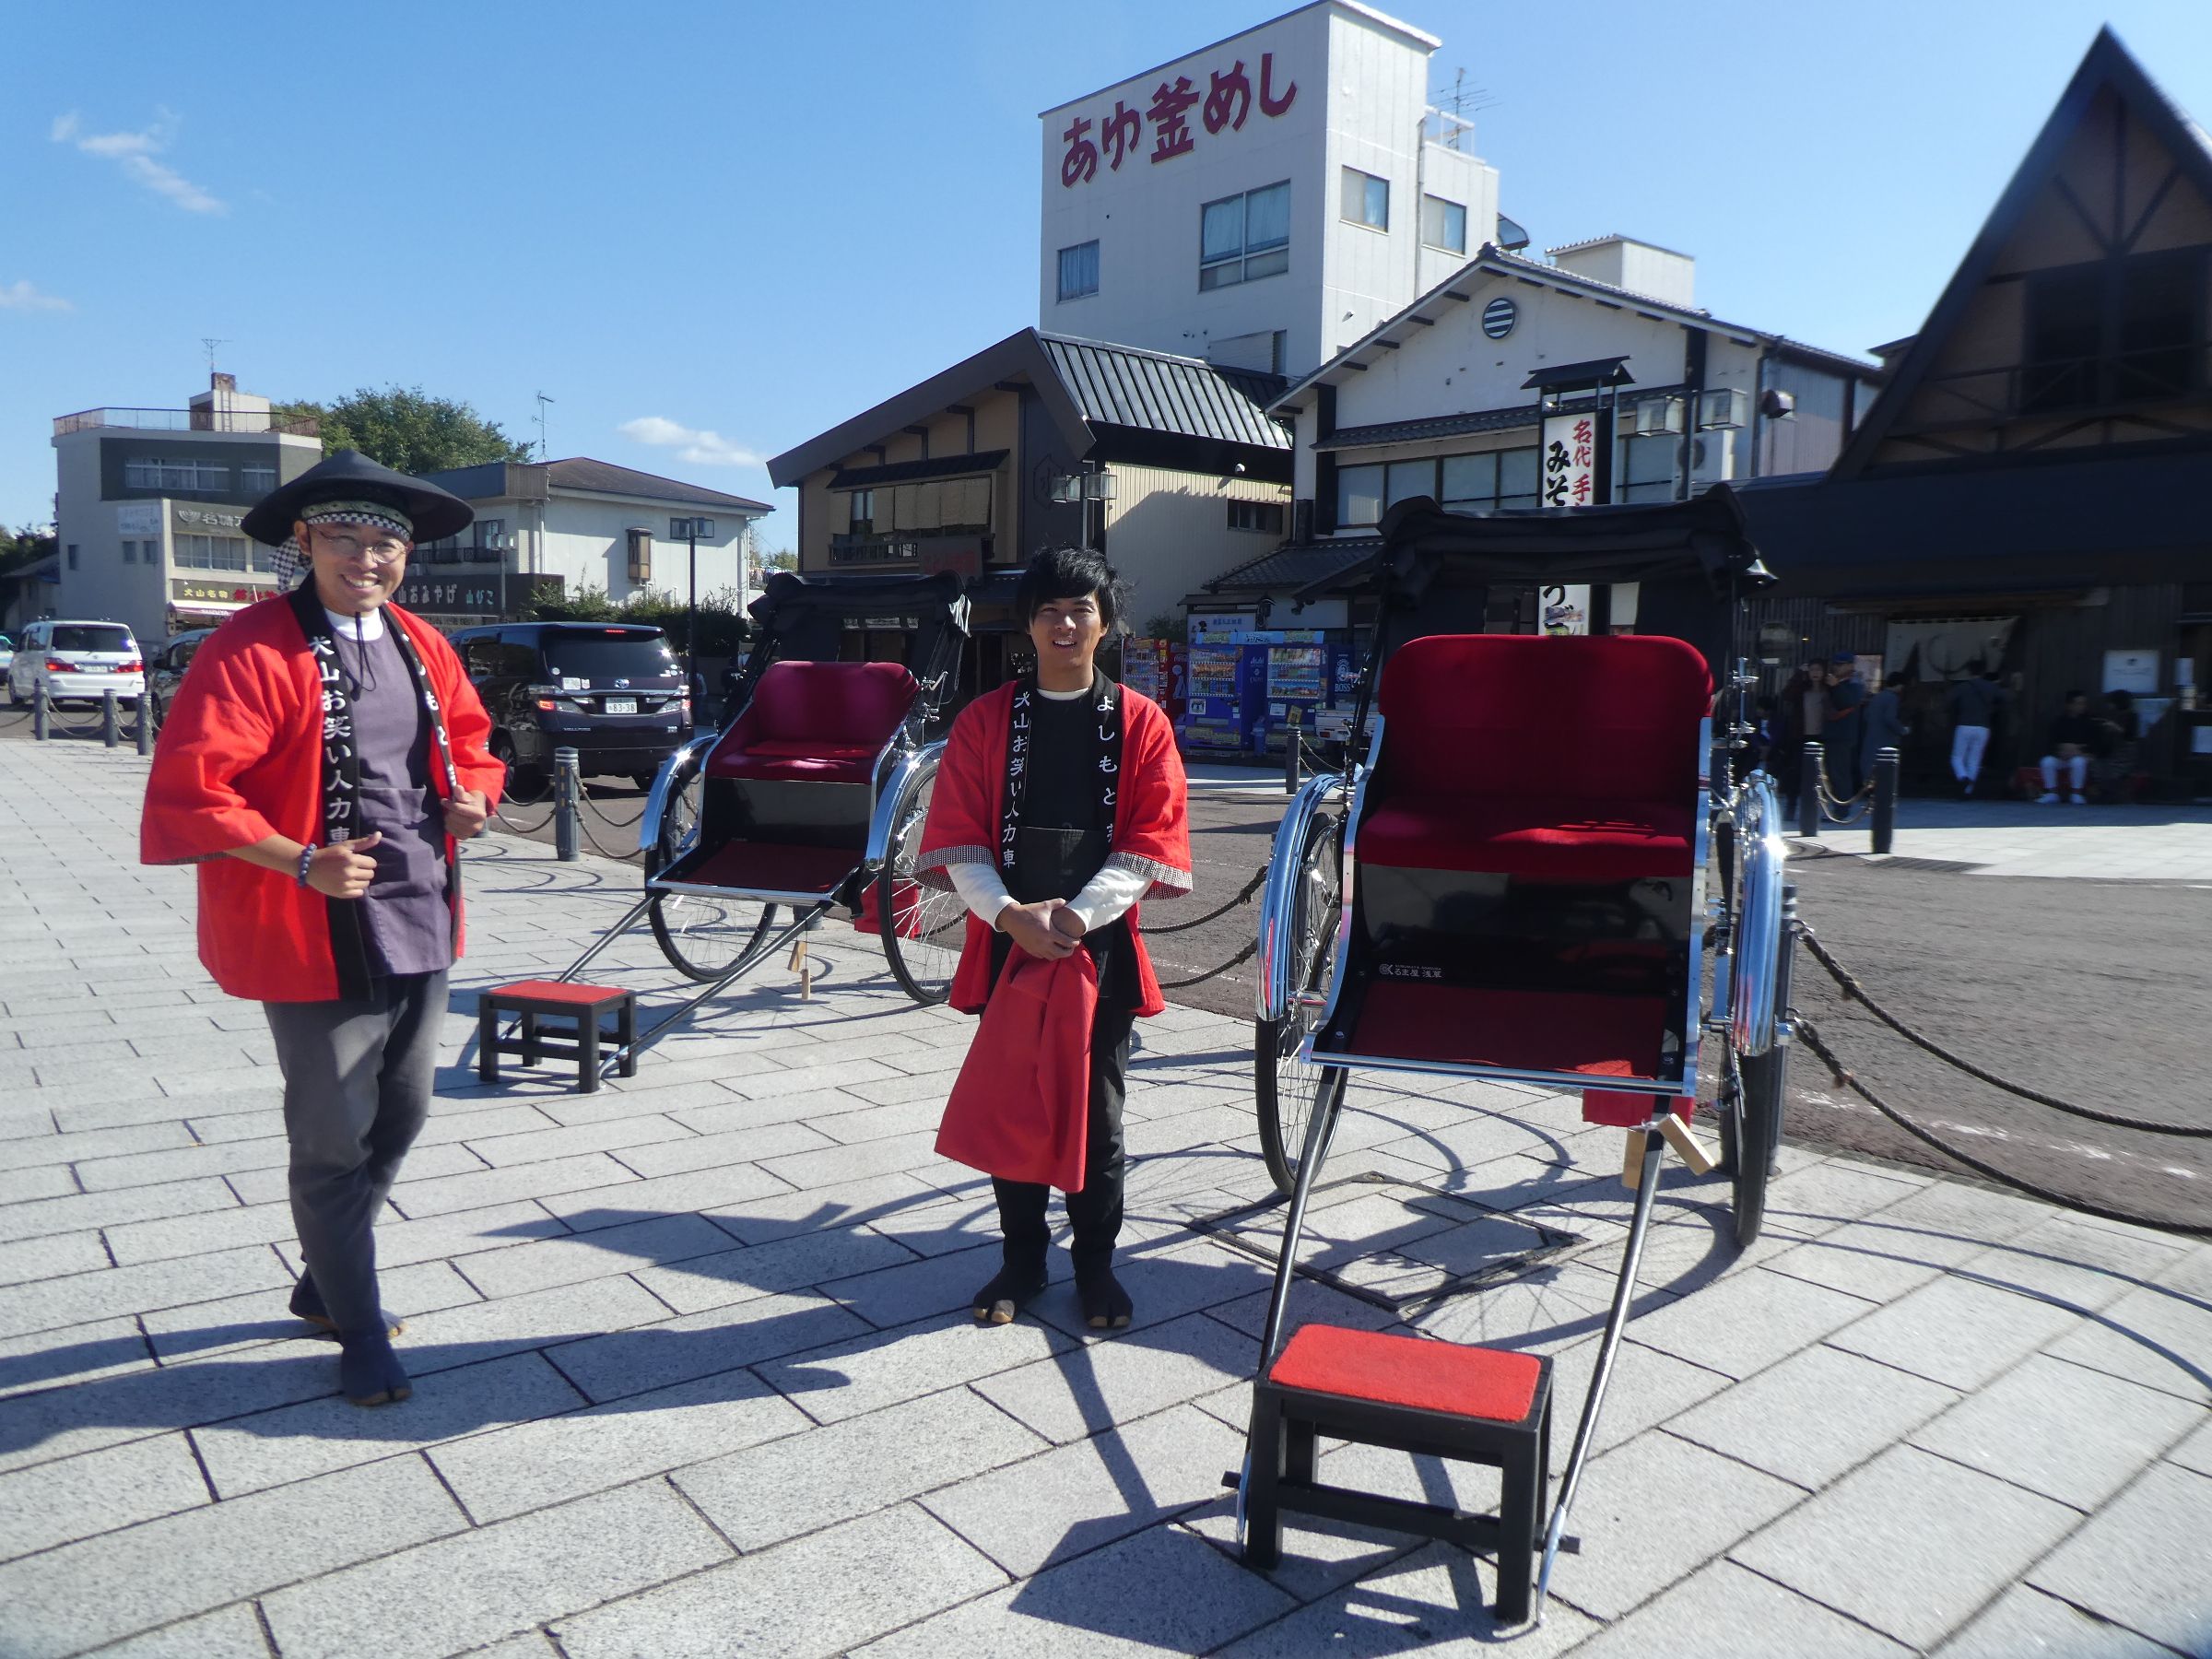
[916,548,1190,1329]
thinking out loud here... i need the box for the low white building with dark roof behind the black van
[411,455,774,624]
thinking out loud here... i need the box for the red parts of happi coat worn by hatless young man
[913,684,1190,1016]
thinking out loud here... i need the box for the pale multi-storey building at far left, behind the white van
[53,374,323,646]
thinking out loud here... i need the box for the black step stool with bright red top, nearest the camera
[1245,1325,1550,1624]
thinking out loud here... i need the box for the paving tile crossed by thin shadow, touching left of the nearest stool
[973,1314,1259,1444]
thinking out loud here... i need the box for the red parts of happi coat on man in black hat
[139,595,507,1002]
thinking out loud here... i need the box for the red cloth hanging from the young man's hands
[938,949,1100,1193]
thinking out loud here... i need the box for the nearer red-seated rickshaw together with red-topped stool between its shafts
[1232,487,1794,1624]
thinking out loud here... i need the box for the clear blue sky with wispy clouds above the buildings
[0,0,2212,535]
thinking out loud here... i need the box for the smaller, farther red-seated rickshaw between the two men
[517,571,969,1071]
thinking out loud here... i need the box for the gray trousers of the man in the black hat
[261,971,444,1336]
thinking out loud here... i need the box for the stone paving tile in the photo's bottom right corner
[2026,1465,2212,1653]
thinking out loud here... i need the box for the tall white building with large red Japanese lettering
[1038,0,1520,378]
